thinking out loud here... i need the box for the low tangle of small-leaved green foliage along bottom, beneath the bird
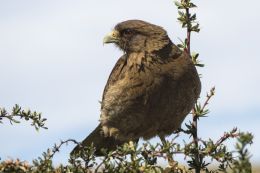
[0,129,253,173]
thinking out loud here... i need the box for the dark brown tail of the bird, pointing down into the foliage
[70,124,126,156]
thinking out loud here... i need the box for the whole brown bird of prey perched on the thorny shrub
[72,20,201,155]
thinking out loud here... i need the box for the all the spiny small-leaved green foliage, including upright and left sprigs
[0,0,253,173]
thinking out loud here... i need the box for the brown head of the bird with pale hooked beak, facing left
[103,20,171,53]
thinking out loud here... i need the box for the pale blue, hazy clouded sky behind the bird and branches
[0,0,260,163]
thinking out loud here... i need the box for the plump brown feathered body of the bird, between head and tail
[100,47,200,140]
